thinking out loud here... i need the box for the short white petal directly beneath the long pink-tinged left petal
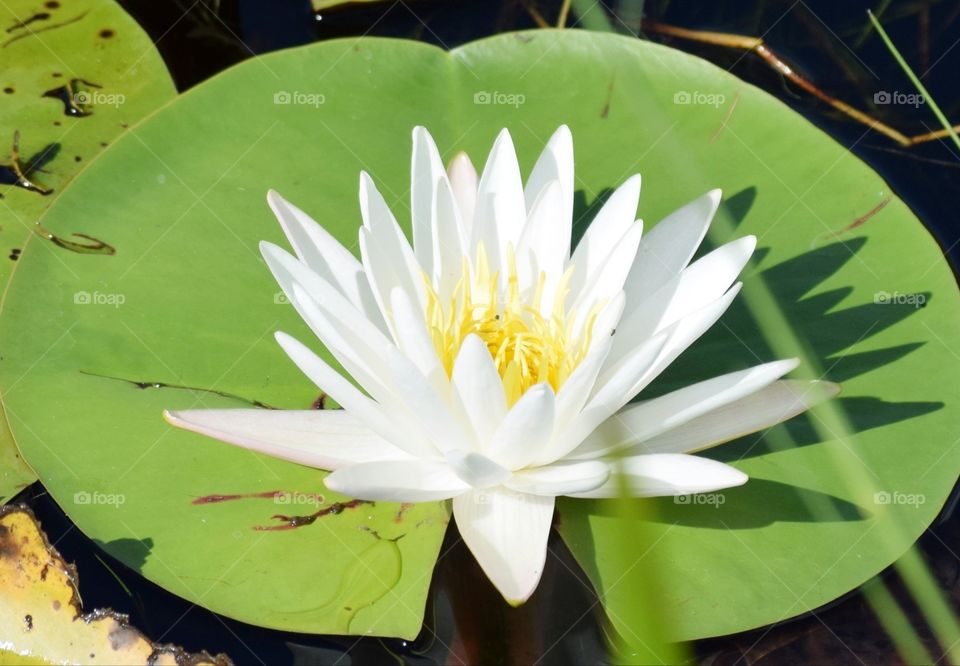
[323,460,470,502]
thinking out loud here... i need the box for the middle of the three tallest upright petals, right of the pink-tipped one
[471,130,527,270]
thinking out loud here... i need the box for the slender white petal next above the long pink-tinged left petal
[276,333,438,457]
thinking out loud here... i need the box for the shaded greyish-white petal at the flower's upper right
[626,190,720,296]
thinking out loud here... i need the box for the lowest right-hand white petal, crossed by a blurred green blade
[571,453,747,497]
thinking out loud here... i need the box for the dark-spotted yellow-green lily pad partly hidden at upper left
[0,0,176,501]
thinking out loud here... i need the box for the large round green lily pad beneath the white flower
[0,31,960,639]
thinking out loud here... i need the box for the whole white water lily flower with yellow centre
[166,126,836,604]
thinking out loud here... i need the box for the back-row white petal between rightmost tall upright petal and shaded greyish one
[570,175,640,293]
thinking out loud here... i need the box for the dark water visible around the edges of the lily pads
[18,0,960,664]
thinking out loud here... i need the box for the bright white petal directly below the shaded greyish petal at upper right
[613,236,757,356]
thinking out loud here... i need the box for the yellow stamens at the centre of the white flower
[424,244,599,405]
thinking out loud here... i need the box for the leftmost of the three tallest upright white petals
[410,127,446,275]
